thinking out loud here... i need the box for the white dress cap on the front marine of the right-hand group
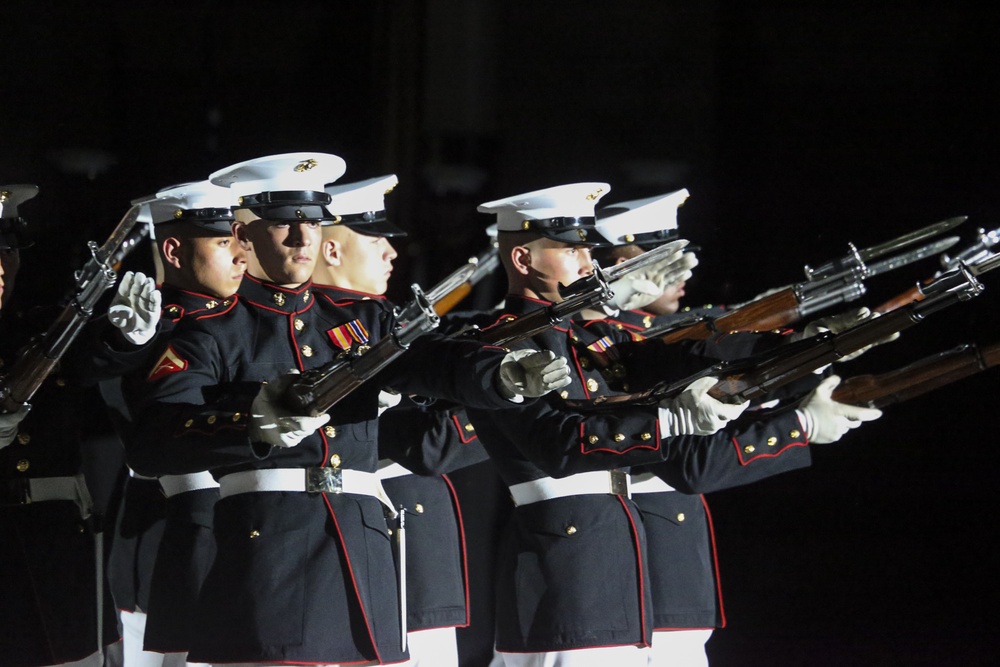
[477,183,611,245]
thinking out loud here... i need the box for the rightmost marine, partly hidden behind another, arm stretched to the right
[594,190,876,667]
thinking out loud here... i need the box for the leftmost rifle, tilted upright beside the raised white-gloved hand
[0,206,141,412]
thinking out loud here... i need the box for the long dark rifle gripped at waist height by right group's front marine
[566,254,1000,410]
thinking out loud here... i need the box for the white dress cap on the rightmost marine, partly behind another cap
[597,189,689,245]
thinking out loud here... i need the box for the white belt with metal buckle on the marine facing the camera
[219,468,397,518]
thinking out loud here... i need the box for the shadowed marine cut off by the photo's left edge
[0,185,118,667]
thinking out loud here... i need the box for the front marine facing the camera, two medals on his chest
[124,154,556,664]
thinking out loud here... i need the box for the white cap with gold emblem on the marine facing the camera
[209,153,347,221]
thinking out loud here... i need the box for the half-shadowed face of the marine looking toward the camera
[236,209,322,287]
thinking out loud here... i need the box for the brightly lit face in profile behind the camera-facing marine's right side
[324,227,396,295]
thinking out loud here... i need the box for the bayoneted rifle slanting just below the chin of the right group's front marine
[463,240,688,347]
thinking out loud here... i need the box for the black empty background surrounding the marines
[0,0,1000,667]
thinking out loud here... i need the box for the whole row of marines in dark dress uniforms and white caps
[0,153,881,666]
